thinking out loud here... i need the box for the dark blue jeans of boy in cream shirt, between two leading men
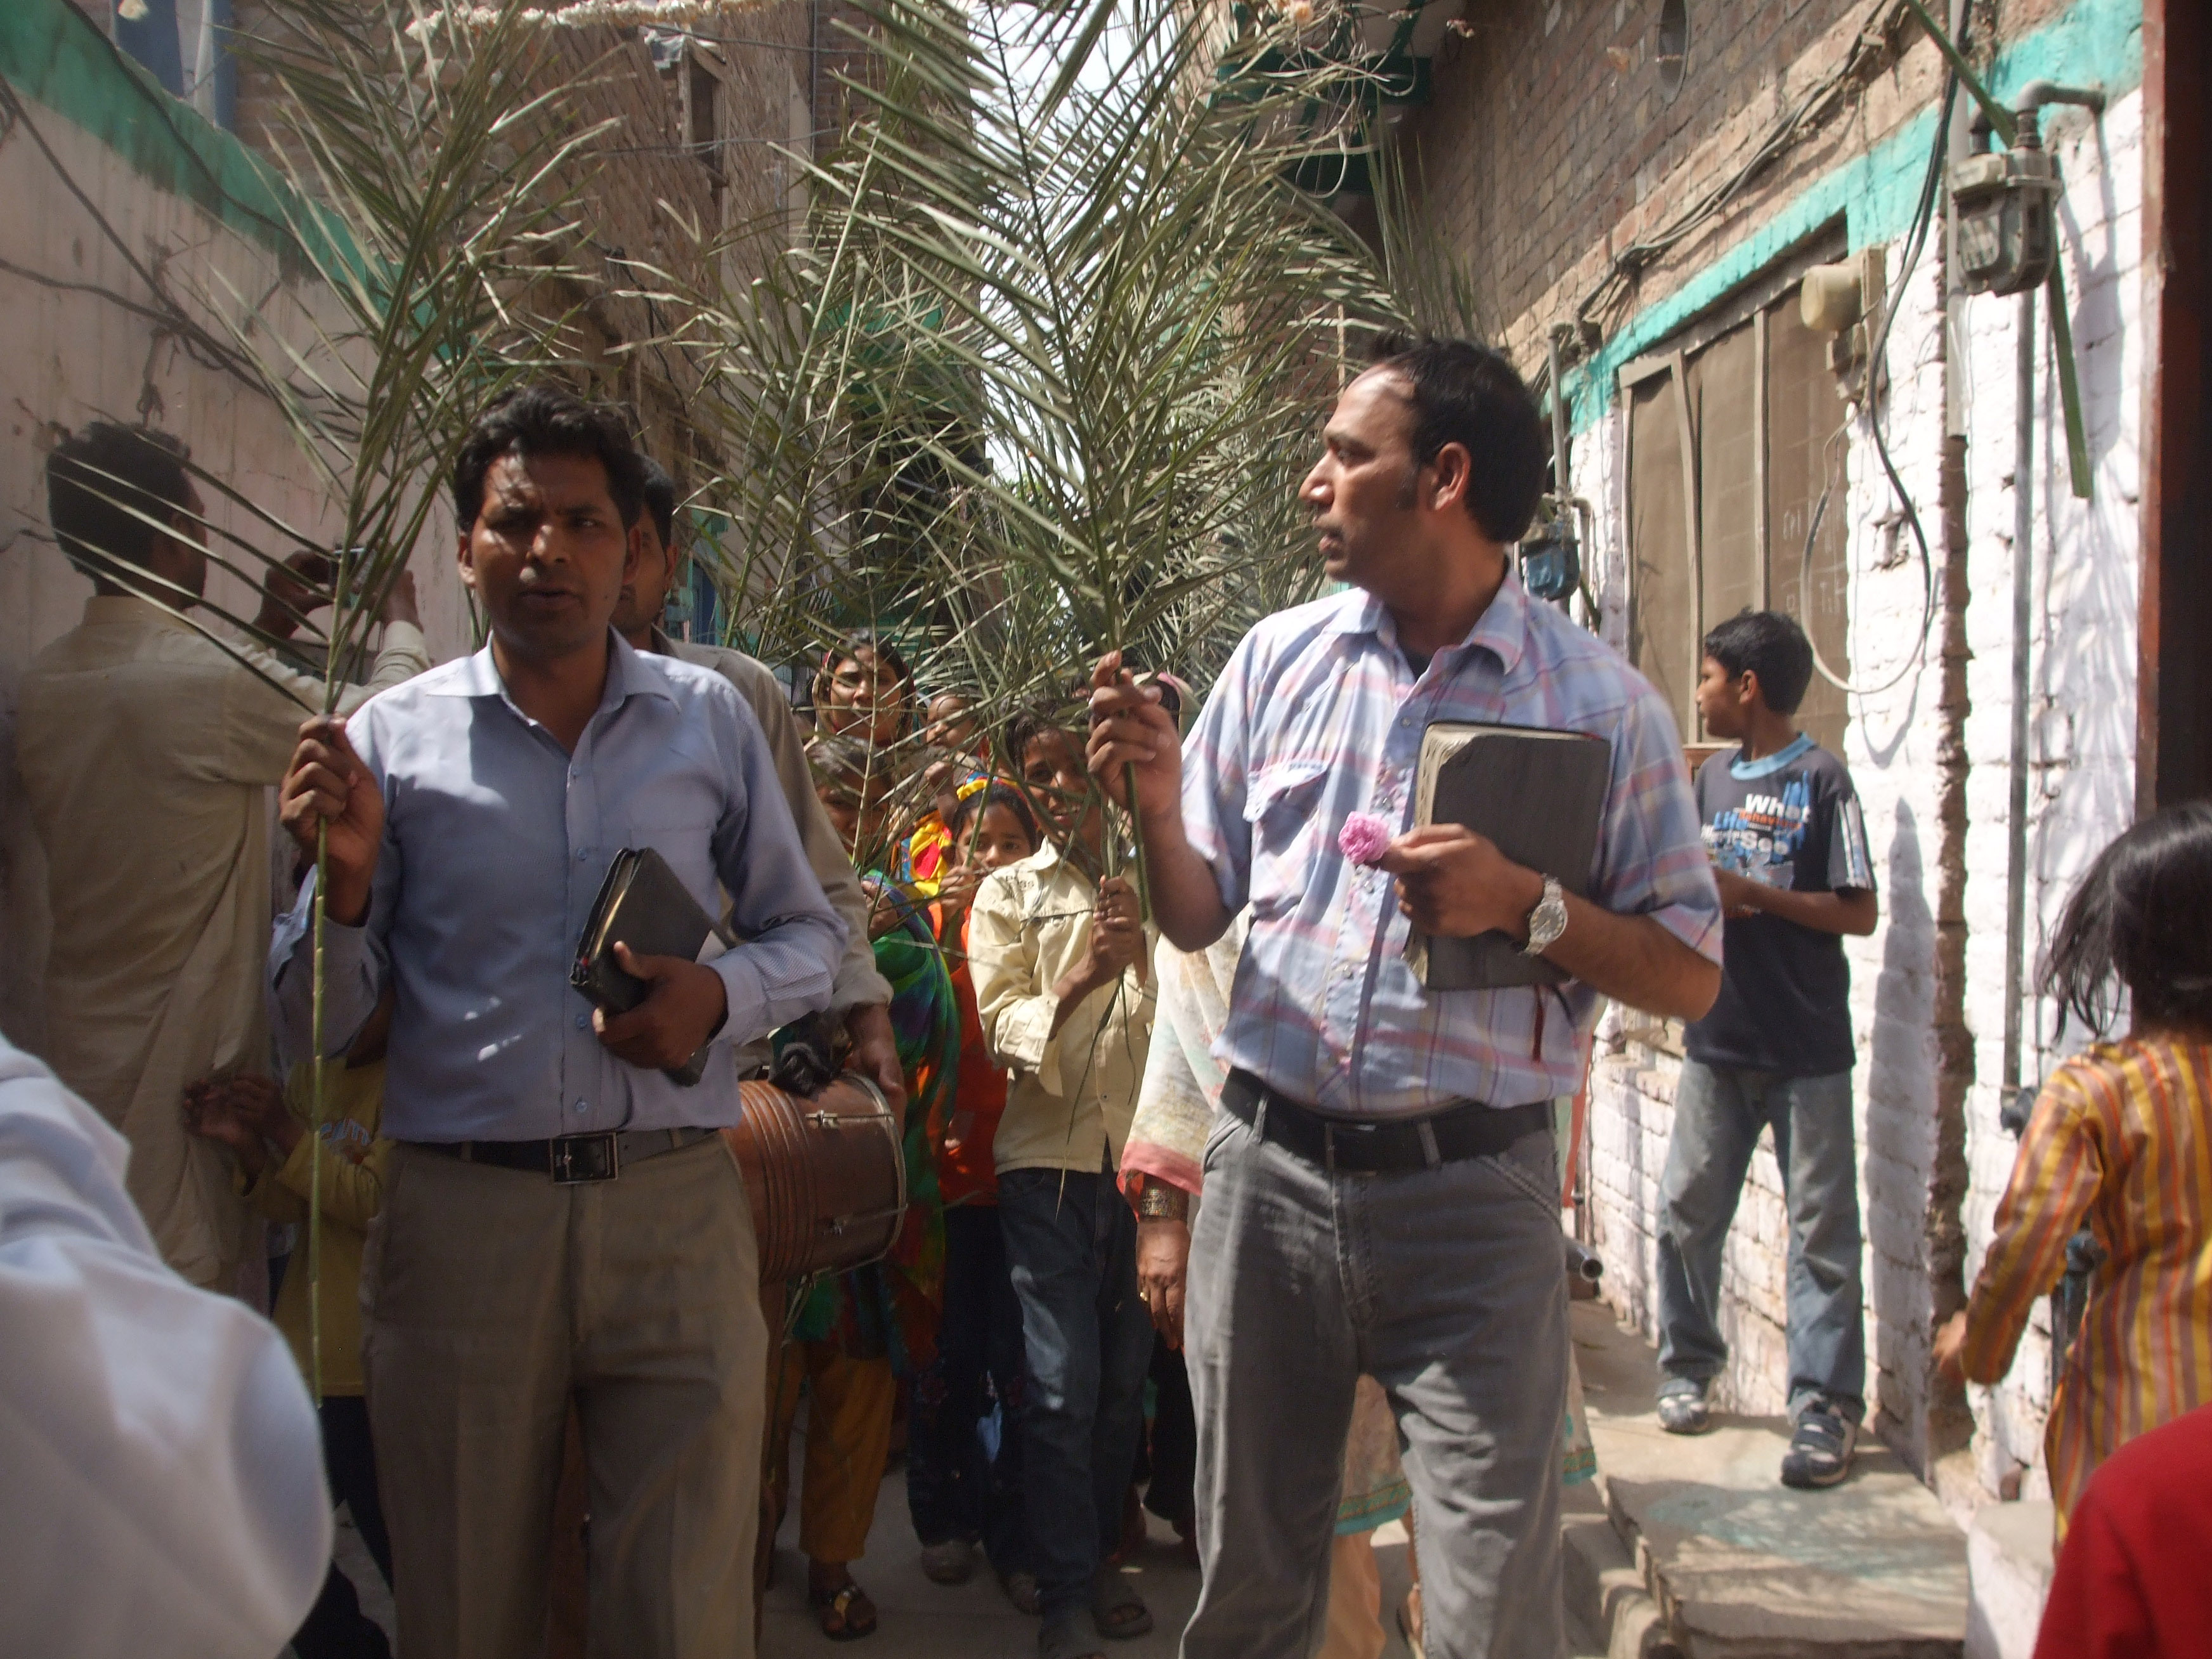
[998,1170,1152,1622]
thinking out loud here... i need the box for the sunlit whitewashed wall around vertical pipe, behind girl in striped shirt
[1964,91,2145,1495]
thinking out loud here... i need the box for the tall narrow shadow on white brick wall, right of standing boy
[1860,801,1935,1464]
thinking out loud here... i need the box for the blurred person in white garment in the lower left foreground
[0,1038,330,1659]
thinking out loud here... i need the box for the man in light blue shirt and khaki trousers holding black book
[270,387,845,1659]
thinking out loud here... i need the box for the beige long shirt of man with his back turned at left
[15,597,429,1290]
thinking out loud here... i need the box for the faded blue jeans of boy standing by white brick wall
[1659,1060,1867,1420]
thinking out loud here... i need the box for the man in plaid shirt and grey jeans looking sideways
[1091,341,1721,1659]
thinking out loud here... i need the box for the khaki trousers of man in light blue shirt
[361,1137,767,1659]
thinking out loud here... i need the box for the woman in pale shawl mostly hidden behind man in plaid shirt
[1121,916,1595,1659]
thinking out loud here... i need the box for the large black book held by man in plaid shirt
[1407,721,1613,991]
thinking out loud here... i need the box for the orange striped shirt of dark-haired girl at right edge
[1964,1039,2212,1537]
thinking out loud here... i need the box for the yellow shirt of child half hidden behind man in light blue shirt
[245,1060,391,1393]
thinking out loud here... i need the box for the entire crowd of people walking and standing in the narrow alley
[0,341,2212,1659]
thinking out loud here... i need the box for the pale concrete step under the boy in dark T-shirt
[1568,1303,1967,1659]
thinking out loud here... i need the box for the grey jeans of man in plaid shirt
[1183,1112,1566,1659]
